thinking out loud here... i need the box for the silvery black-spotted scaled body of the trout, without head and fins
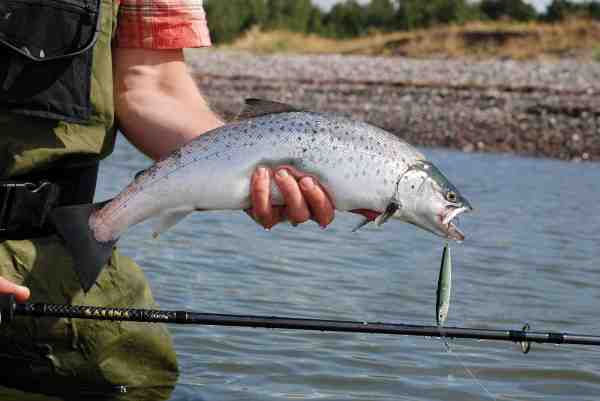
[90,112,424,240]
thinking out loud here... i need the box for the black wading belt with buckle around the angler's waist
[0,162,98,241]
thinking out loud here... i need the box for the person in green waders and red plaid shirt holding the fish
[0,0,333,400]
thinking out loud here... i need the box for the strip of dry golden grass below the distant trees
[221,19,600,61]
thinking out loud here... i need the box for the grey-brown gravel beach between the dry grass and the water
[187,49,600,161]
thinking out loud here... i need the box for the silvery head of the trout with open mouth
[394,160,473,241]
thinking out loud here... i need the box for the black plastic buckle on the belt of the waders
[0,181,60,239]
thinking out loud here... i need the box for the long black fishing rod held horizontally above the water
[0,295,600,353]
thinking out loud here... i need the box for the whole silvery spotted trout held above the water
[51,99,472,291]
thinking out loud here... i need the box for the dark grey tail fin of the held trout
[50,202,117,292]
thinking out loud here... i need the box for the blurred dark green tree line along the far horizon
[204,0,600,43]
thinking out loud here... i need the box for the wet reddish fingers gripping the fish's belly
[246,166,335,229]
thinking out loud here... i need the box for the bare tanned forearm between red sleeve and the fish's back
[114,49,223,160]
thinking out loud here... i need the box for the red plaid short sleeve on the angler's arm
[115,0,211,49]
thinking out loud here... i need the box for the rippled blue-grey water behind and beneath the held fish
[98,135,600,401]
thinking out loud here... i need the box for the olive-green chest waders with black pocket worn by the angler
[0,0,177,400]
